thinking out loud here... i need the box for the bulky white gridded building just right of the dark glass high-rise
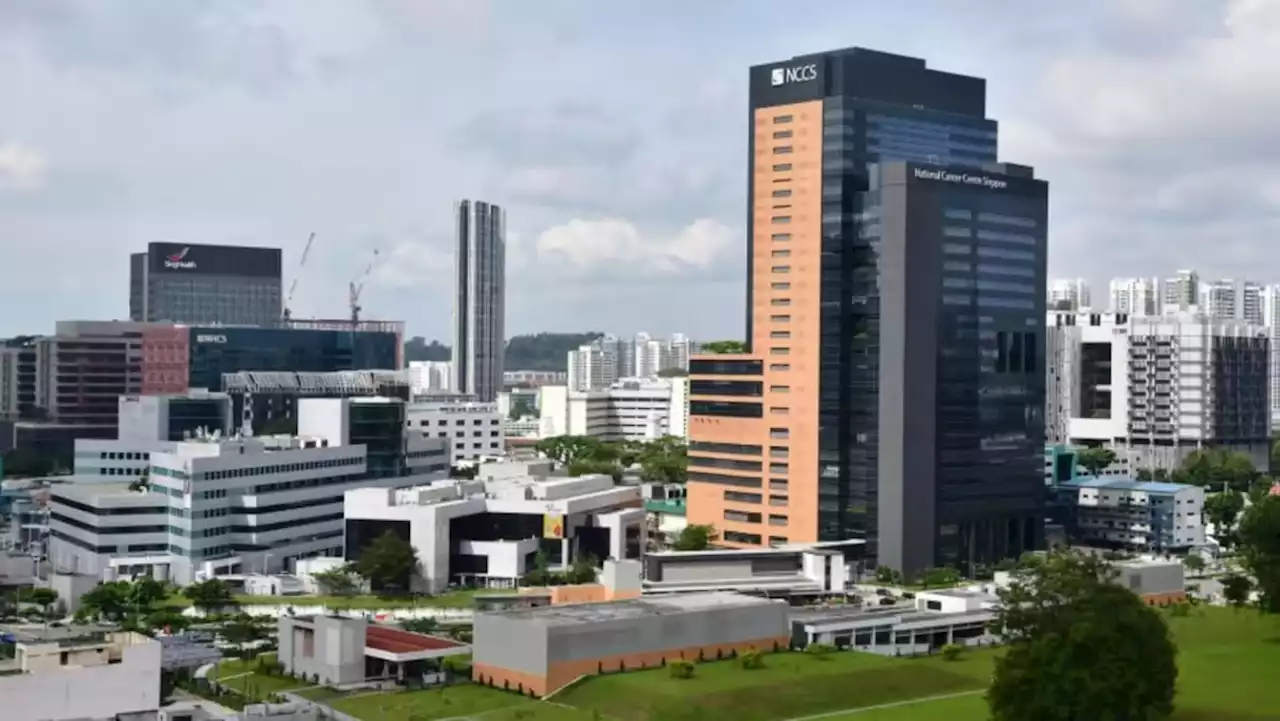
[1046,311,1271,470]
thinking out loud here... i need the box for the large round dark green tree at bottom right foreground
[987,551,1178,721]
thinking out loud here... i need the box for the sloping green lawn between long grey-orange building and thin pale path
[556,652,991,721]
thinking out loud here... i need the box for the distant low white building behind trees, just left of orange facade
[538,378,689,441]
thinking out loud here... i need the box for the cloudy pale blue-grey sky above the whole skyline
[0,0,1280,338]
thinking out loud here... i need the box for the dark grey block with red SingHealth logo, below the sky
[129,243,283,325]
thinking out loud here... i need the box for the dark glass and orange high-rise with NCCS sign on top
[689,49,1048,572]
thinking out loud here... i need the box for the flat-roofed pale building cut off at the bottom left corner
[0,629,163,721]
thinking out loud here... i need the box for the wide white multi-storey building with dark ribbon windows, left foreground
[49,398,449,584]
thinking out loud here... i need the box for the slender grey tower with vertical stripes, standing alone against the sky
[452,200,507,403]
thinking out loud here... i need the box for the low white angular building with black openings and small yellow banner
[344,464,645,593]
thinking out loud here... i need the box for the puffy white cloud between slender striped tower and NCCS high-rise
[535,218,736,275]
